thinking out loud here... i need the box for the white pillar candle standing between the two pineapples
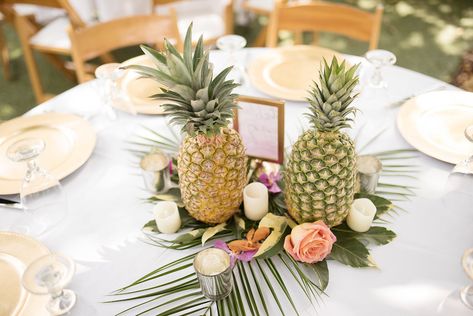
[243,182,268,221]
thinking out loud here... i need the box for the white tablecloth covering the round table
[0,49,473,316]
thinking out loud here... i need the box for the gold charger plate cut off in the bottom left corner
[0,232,49,316]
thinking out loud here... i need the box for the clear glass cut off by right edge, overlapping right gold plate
[447,125,473,199]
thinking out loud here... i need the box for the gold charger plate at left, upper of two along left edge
[0,113,96,195]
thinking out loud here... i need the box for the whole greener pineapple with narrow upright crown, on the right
[284,57,358,227]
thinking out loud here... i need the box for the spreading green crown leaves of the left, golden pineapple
[126,23,238,136]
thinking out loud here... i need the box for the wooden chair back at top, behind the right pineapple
[267,0,383,49]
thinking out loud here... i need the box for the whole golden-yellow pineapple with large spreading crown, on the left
[129,24,247,224]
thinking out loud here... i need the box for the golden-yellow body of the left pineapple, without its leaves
[178,128,247,224]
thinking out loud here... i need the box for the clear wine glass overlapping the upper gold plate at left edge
[7,138,67,236]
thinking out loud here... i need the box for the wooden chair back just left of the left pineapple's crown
[69,12,182,83]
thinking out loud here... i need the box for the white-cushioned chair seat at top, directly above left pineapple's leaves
[152,0,233,45]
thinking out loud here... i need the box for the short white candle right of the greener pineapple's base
[347,198,376,233]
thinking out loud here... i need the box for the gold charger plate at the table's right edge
[397,90,473,164]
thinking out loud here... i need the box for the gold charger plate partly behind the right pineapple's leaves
[248,45,343,101]
